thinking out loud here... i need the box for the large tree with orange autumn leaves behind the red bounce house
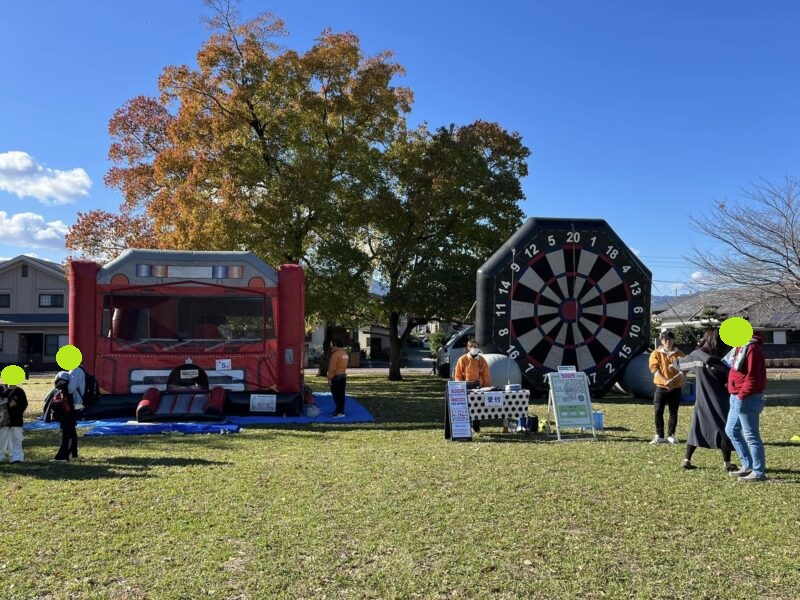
[67,0,411,328]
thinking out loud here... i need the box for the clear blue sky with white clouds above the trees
[0,0,800,294]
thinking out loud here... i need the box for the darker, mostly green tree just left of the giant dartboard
[364,121,530,380]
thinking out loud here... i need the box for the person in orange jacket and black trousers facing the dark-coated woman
[649,331,684,444]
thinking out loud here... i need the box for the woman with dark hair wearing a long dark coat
[677,329,737,471]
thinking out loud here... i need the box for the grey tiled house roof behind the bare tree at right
[658,291,800,328]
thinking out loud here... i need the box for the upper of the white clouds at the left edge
[0,151,92,205]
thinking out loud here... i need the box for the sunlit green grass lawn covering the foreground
[0,376,800,599]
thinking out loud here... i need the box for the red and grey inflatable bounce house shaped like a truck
[69,250,305,421]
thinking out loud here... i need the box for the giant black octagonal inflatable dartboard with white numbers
[476,219,651,396]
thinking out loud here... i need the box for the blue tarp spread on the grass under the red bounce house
[24,392,375,437]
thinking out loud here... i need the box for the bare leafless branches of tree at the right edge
[689,172,800,308]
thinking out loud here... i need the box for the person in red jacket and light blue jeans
[725,333,767,482]
